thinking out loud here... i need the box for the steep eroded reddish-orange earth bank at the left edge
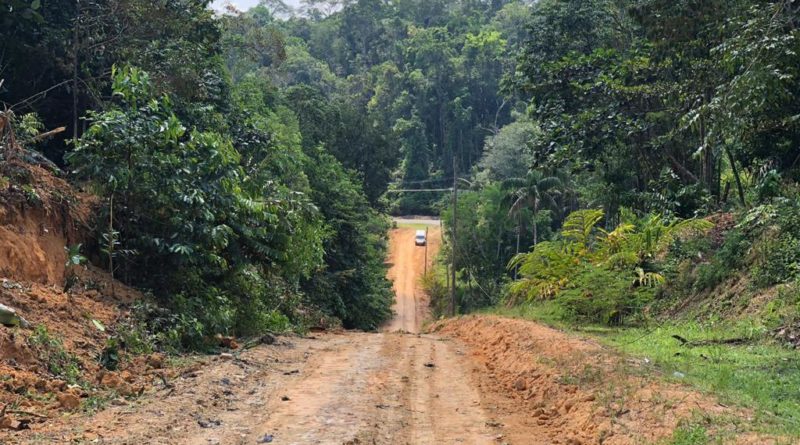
[0,161,163,434]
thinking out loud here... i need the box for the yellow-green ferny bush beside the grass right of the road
[509,209,711,324]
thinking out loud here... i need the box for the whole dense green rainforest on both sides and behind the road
[0,0,800,346]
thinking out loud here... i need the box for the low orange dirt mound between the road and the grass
[432,316,774,444]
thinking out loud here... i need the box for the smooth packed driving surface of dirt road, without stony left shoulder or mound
[220,227,498,444]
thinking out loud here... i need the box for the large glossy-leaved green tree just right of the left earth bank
[69,68,321,345]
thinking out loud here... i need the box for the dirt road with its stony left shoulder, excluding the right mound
[6,226,500,444]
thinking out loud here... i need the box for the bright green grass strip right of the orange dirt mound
[484,303,800,443]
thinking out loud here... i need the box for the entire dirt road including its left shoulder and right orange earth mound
[0,228,772,445]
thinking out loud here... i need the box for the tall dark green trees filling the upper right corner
[508,0,800,217]
